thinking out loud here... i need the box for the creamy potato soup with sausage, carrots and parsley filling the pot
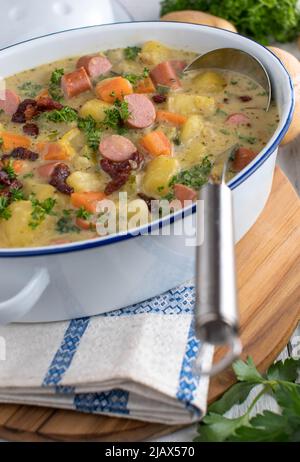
[0,41,279,248]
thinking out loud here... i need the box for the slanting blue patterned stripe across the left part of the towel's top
[42,318,90,391]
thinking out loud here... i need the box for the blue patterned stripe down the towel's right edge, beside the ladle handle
[176,320,200,414]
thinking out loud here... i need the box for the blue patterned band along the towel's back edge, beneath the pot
[102,286,195,317]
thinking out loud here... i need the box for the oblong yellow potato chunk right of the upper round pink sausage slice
[168,93,215,116]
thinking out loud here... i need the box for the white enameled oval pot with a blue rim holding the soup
[0,22,294,323]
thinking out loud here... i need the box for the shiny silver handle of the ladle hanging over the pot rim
[195,183,241,375]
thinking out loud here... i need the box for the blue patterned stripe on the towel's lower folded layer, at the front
[74,389,129,415]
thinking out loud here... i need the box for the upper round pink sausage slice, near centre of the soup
[124,93,156,128]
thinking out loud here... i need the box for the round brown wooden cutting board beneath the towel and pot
[0,168,300,442]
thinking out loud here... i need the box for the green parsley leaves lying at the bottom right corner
[195,358,300,442]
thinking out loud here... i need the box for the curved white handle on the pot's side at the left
[0,268,50,325]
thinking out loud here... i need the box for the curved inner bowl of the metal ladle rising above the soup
[183,48,272,111]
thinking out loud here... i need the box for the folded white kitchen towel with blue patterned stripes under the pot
[0,283,213,424]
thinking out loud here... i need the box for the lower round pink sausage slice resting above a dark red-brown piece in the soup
[99,135,137,162]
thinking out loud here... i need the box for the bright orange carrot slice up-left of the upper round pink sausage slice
[96,77,133,103]
